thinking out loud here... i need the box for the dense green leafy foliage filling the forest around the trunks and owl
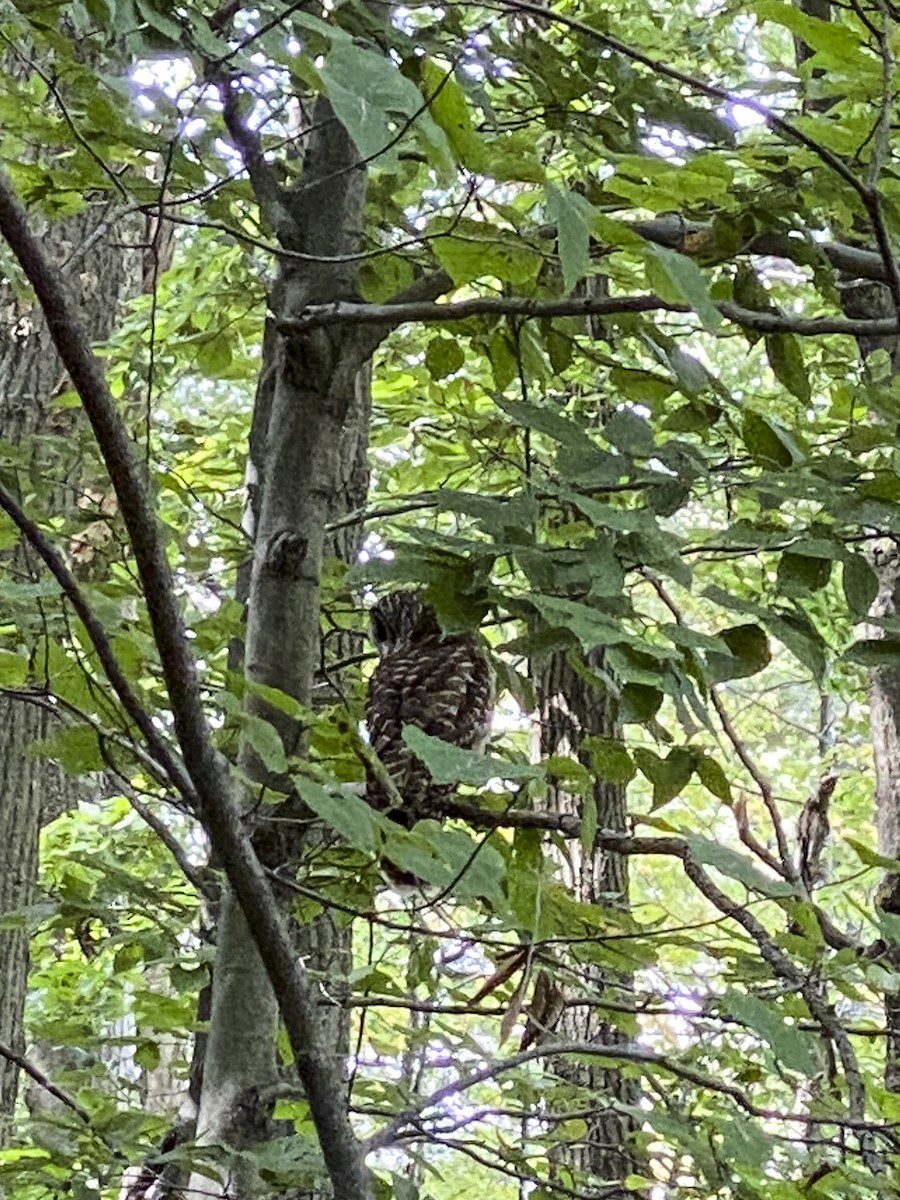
[0,0,900,1200]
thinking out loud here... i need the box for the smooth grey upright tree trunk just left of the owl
[193,100,370,1200]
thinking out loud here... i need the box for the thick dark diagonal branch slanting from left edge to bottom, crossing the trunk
[0,173,372,1200]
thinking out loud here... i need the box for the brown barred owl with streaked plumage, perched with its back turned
[366,590,493,826]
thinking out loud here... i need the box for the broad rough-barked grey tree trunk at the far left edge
[0,205,142,1144]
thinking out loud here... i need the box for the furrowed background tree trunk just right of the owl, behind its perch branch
[535,650,640,1196]
